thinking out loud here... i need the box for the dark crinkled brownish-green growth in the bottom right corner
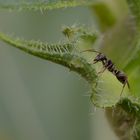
[106,97,140,140]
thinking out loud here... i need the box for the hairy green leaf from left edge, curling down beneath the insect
[0,33,124,107]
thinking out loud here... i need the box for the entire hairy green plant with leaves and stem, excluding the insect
[0,0,140,140]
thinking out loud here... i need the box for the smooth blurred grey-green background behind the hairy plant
[0,0,121,140]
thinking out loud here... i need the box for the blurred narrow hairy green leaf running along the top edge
[0,0,94,11]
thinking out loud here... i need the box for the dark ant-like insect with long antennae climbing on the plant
[82,49,130,96]
